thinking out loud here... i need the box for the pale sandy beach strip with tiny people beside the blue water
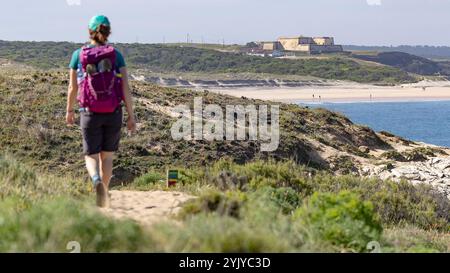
[212,81,450,103]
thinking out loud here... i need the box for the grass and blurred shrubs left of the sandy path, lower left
[0,152,156,252]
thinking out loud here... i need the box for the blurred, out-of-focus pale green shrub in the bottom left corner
[0,198,154,252]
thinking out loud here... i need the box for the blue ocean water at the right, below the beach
[301,101,450,147]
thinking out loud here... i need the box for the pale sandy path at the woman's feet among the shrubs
[100,191,194,225]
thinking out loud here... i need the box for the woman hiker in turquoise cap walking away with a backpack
[66,15,136,207]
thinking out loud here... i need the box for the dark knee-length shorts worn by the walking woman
[80,107,122,155]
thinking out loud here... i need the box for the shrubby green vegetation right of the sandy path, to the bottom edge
[123,161,450,252]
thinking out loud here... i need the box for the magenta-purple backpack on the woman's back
[78,45,123,113]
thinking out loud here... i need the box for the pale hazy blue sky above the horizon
[0,0,450,46]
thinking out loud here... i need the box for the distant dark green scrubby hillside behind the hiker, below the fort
[0,41,416,84]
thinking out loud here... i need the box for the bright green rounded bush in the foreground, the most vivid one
[294,191,382,251]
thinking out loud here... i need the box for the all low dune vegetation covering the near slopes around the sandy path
[0,68,450,252]
